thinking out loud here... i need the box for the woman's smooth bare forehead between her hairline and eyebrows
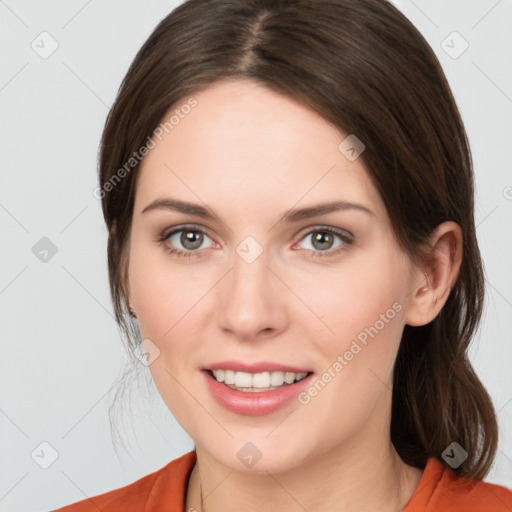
[136,80,384,216]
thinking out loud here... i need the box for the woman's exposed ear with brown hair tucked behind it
[405,221,462,326]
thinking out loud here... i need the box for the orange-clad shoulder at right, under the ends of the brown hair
[404,457,512,512]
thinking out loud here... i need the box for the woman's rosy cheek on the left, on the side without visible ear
[129,242,206,424]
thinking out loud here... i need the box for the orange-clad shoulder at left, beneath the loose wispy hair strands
[54,451,196,512]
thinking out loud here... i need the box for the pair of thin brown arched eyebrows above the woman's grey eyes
[141,197,377,223]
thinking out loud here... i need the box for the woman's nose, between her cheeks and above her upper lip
[217,246,290,341]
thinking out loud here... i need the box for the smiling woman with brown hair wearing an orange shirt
[54,0,512,512]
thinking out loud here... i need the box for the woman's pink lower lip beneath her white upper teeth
[203,371,313,416]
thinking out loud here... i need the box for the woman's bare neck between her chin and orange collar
[186,400,422,512]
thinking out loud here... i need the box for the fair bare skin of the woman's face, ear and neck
[125,80,462,512]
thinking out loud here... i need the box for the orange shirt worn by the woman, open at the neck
[54,451,512,512]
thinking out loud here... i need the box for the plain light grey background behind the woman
[0,0,512,512]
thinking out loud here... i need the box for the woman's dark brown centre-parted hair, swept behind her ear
[100,0,498,479]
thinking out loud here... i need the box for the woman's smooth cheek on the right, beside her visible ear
[304,253,406,400]
